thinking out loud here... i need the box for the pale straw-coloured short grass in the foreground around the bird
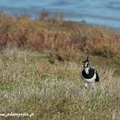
[0,48,120,120]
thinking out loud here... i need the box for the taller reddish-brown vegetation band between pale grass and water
[0,11,120,63]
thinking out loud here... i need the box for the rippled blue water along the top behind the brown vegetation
[0,0,120,30]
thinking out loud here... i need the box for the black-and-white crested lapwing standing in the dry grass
[81,56,99,88]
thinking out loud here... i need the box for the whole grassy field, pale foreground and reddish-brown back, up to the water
[0,12,120,120]
